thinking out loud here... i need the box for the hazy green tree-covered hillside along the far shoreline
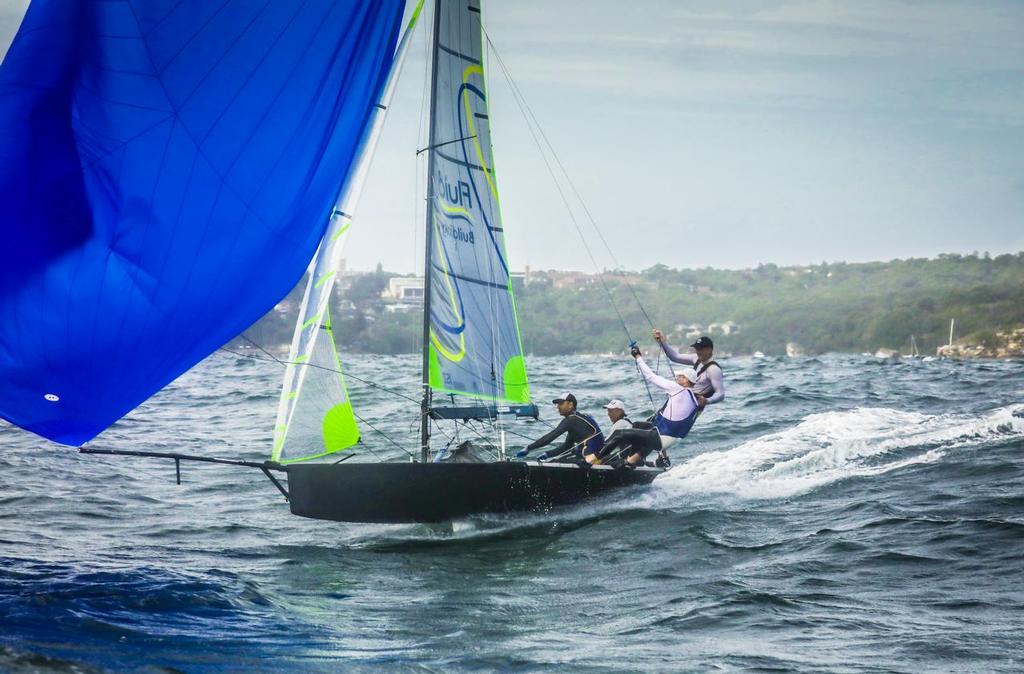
[241,253,1024,354]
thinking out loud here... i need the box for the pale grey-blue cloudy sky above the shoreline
[0,0,1024,272]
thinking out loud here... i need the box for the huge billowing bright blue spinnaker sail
[0,0,403,445]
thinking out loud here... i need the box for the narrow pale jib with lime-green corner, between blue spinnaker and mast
[270,0,423,463]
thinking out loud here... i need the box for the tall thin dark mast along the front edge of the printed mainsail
[420,0,441,463]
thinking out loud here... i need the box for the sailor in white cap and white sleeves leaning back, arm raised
[599,346,700,466]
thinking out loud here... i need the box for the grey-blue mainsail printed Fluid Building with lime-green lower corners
[427,0,529,403]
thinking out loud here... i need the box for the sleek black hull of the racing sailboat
[288,461,664,522]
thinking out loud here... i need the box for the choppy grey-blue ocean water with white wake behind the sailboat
[0,352,1024,672]
